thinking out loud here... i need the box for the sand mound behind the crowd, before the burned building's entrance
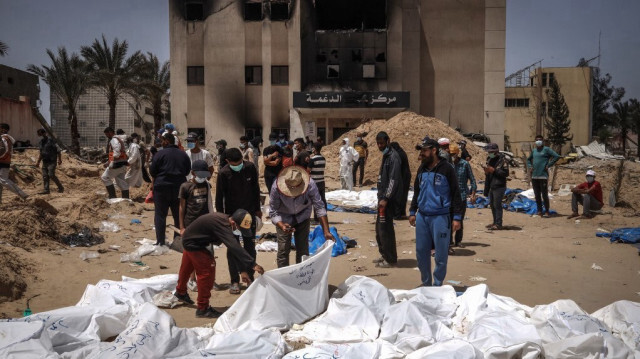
[322,112,486,186]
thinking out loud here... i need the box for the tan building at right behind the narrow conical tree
[504,67,593,154]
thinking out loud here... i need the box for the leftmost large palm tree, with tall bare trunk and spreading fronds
[27,47,89,154]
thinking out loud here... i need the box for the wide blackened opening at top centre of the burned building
[315,0,387,30]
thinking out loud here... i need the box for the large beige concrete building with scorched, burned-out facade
[169,0,506,145]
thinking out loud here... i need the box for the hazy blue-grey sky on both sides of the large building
[0,0,640,122]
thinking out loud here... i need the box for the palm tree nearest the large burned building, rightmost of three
[136,52,170,131]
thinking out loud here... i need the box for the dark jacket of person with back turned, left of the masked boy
[149,145,191,187]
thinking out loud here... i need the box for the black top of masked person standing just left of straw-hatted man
[216,161,260,215]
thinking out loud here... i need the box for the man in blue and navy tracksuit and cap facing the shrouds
[409,138,462,286]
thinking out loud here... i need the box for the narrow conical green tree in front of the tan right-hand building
[544,80,573,153]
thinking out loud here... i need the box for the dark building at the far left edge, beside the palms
[0,65,42,146]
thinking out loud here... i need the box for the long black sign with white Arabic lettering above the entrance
[293,92,409,108]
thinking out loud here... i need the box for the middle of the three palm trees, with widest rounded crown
[80,35,144,128]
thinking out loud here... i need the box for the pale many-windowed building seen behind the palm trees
[51,89,160,147]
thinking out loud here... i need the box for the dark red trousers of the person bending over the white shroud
[176,250,216,310]
